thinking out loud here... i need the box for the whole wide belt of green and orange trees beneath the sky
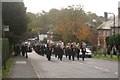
[27,5,102,45]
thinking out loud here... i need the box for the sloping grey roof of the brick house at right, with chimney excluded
[97,16,118,29]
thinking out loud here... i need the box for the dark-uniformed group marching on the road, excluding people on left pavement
[34,42,86,61]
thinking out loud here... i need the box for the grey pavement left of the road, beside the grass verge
[9,55,38,80]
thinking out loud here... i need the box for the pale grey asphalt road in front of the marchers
[29,52,118,78]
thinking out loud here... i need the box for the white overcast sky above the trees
[24,0,120,16]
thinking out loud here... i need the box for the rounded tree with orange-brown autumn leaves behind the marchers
[50,6,89,42]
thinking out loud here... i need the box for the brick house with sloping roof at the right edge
[97,16,120,45]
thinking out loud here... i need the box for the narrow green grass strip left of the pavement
[2,58,13,78]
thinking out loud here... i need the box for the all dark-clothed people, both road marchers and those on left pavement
[14,41,86,61]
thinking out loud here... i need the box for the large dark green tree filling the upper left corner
[2,2,27,43]
